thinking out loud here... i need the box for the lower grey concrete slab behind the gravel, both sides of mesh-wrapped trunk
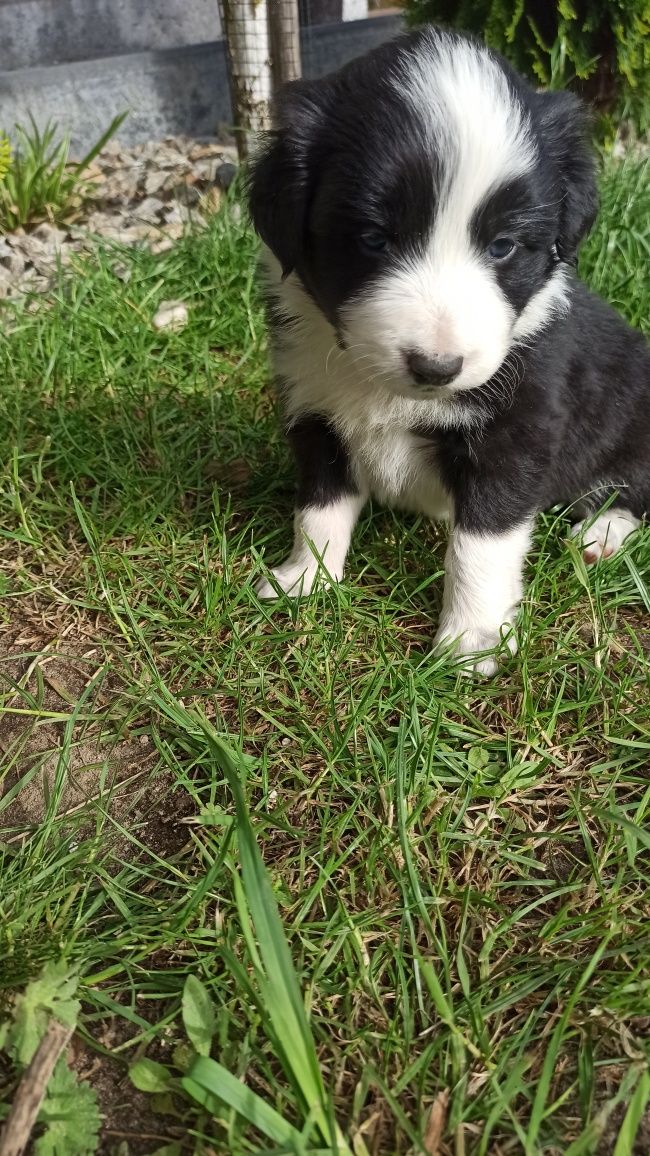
[0,12,401,155]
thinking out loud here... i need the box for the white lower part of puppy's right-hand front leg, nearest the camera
[434,518,533,675]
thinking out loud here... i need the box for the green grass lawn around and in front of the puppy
[0,156,650,1156]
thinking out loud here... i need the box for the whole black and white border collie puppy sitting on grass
[245,27,650,674]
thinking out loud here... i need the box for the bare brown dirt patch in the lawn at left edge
[0,618,155,839]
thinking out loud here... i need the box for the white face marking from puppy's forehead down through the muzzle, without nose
[333,31,542,392]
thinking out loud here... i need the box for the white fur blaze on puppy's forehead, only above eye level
[392,31,537,234]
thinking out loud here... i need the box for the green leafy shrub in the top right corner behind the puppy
[406,0,650,132]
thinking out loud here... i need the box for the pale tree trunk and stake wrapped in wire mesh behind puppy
[219,0,301,158]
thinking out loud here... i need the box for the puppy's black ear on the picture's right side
[539,92,598,264]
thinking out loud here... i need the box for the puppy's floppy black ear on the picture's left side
[249,81,324,276]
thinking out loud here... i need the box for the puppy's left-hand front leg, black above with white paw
[256,416,368,598]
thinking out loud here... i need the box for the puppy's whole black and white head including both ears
[250,28,596,397]
